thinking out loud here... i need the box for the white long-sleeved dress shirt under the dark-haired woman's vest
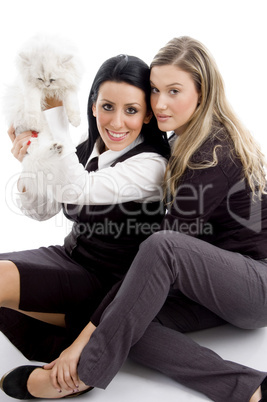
[18,107,167,220]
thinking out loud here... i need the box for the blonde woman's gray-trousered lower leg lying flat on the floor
[130,322,267,402]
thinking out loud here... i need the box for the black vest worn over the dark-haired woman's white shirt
[63,143,165,280]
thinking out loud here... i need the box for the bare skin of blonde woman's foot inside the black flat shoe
[27,368,90,399]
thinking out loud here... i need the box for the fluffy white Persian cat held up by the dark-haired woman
[2,35,82,207]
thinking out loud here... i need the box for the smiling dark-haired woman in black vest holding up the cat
[0,55,169,398]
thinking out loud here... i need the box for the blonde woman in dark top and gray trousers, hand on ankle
[2,37,267,402]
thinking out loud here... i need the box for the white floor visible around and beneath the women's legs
[0,326,267,402]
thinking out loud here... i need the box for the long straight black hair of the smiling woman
[77,55,170,164]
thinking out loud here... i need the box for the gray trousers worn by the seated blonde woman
[78,231,267,402]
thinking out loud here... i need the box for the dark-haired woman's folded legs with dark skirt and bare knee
[0,246,111,362]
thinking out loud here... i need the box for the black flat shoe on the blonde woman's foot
[0,366,93,400]
